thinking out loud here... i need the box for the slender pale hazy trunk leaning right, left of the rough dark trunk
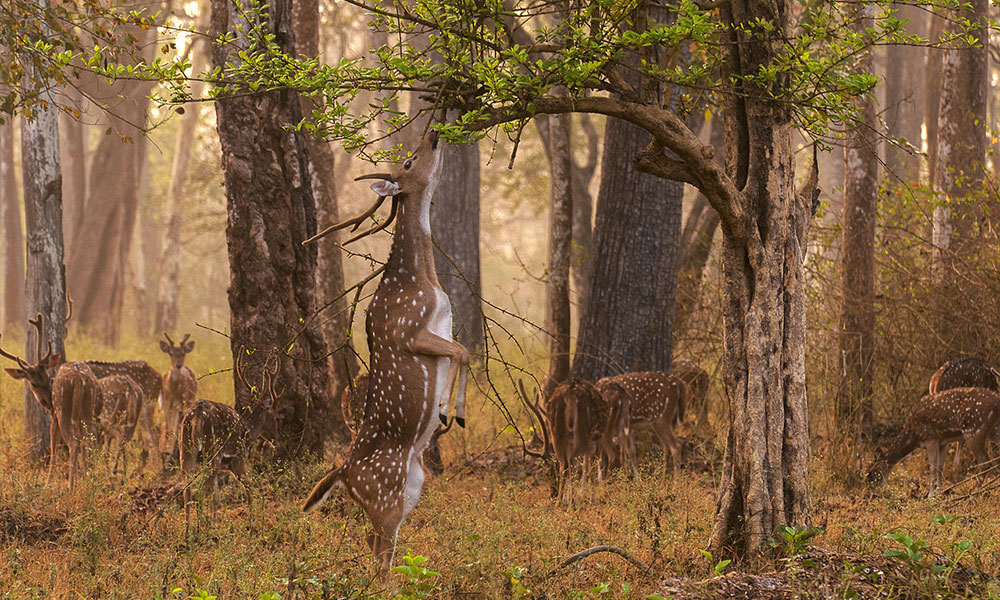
[153,47,208,333]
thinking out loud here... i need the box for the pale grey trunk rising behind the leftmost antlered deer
[21,77,66,460]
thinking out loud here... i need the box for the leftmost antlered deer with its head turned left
[0,313,101,489]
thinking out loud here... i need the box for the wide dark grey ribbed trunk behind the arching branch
[572,118,684,380]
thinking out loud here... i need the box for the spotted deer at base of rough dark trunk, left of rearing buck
[179,350,279,533]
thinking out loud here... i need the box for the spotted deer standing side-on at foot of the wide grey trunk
[597,371,688,477]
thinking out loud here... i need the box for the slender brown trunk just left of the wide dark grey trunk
[543,109,573,397]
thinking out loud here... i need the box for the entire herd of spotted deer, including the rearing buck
[0,133,1000,577]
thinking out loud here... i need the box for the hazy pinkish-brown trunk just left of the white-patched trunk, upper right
[888,4,926,181]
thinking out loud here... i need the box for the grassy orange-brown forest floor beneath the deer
[0,366,1000,600]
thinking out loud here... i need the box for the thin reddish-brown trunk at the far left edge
[0,118,26,327]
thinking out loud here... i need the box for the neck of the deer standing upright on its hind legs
[385,190,440,287]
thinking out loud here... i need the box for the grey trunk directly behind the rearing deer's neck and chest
[431,139,483,353]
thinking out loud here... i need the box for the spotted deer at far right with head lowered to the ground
[867,387,1000,496]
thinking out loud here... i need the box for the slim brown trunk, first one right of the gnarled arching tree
[835,4,876,433]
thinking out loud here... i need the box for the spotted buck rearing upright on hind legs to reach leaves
[303,133,469,579]
